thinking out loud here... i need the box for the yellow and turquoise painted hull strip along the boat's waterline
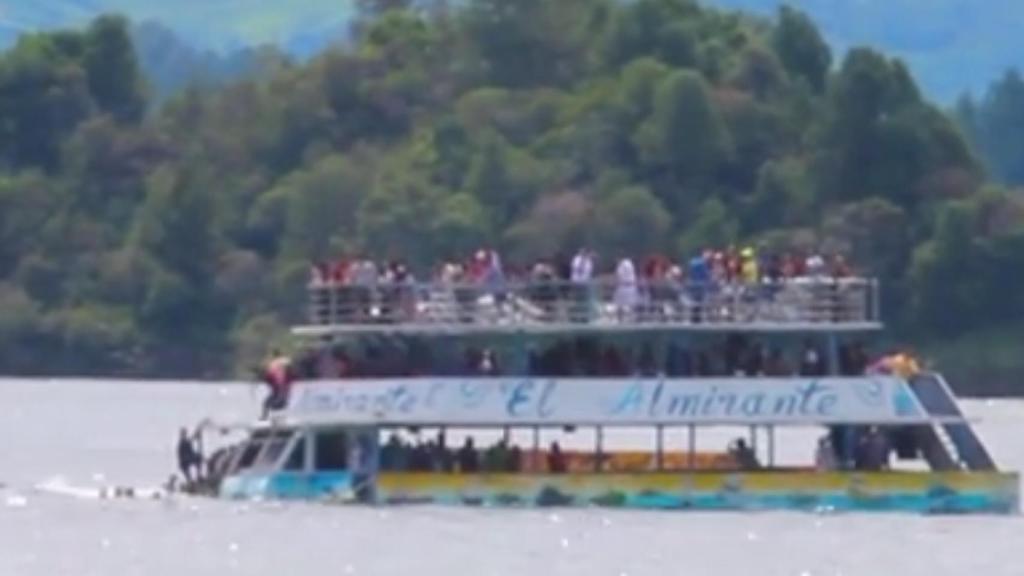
[221,471,1020,513]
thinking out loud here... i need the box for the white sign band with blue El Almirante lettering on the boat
[287,377,929,425]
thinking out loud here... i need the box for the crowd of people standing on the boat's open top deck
[309,247,854,323]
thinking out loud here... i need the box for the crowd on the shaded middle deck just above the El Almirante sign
[259,334,872,389]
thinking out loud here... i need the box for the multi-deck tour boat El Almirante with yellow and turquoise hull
[195,266,1020,515]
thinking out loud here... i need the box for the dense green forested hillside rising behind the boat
[0,0,1024,384]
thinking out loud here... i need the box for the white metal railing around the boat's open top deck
[308,277,880,328]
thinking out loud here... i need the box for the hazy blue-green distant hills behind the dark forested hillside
[0,0,1024,99]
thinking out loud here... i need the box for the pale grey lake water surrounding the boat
[0,380,1024,576]
